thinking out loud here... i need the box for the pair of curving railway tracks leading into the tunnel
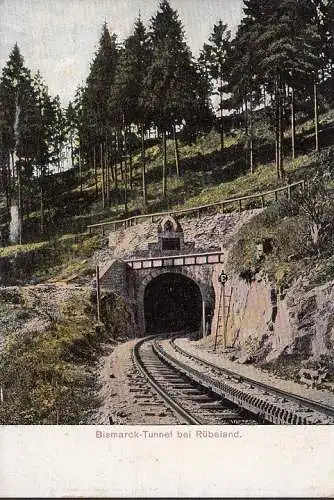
[132,336,334,425]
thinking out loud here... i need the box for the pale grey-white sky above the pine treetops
[0,0,242,105]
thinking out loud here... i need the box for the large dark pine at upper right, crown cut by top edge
[234,0,319,177]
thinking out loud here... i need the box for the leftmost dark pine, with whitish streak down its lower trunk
[0,45,63,243]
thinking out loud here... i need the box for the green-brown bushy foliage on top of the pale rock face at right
[228,180,334,288]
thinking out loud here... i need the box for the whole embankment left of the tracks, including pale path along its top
[0,283,133,424]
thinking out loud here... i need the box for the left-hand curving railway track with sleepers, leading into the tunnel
[132,337,258,425]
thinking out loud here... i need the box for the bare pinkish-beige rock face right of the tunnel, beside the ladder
[207,274,334,378]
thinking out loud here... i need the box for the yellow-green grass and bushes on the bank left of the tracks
[0,297,130,425]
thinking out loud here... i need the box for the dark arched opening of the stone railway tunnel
[144,273,203,333]
